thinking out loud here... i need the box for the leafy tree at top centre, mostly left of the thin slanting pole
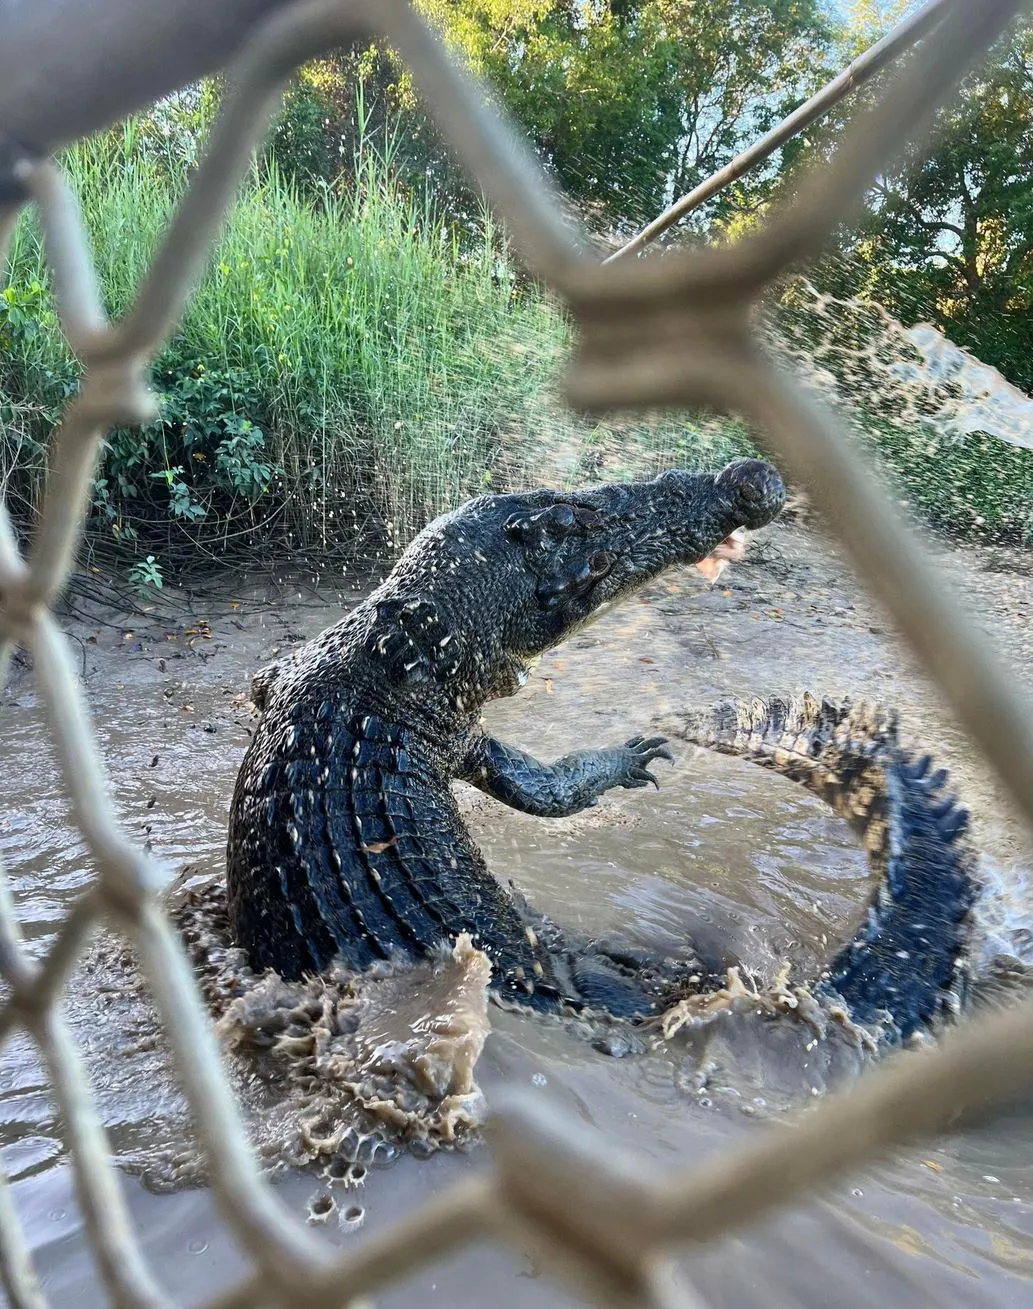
[420,0,833,225]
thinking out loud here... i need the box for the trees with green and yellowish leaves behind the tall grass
[260,0,1033,389]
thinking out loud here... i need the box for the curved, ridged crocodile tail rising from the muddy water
[664,695,978,1041]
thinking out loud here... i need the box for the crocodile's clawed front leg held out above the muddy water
[457,736,674,818]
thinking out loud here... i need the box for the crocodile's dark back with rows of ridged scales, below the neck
[227,690,563,1008]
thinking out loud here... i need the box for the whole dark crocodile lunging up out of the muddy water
[227,459,974,1037]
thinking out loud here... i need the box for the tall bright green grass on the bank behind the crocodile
[0,123,742,568]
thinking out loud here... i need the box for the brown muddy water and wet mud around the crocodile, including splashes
[0,515,1033,1305]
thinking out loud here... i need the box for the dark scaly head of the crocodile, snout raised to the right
[367,459,786,711]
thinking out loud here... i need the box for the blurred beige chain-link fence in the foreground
[0,0,1033,1309]
